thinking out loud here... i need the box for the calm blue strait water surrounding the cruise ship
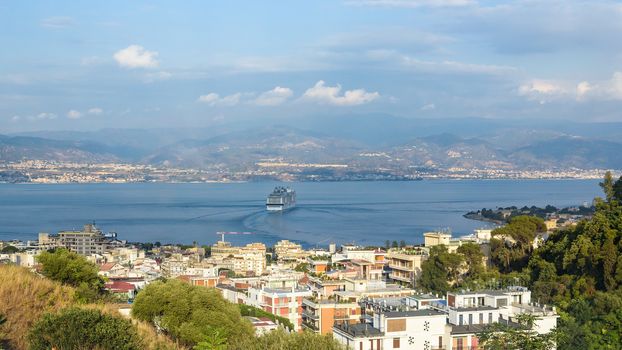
[0,180,600,246]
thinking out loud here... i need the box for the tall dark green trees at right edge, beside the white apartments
[529,173,622,349]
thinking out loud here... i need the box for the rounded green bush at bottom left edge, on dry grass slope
[28,308,142,350]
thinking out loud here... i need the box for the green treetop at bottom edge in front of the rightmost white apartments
[477,314,557,350]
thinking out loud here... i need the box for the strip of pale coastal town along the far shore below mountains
[0,160,606,184]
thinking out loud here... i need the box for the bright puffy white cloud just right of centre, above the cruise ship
[302,80,380,106]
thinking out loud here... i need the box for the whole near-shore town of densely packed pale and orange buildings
[0,224,559,350]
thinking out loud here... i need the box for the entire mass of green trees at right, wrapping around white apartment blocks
[419,173,622,350]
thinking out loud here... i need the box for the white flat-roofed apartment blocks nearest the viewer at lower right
[333,287,559,350]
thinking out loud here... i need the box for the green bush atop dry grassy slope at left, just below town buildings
[37,249,105,302]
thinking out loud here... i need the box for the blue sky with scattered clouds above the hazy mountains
[0,0,622,133]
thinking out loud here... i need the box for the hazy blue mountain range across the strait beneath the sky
[0,115,622,170]
